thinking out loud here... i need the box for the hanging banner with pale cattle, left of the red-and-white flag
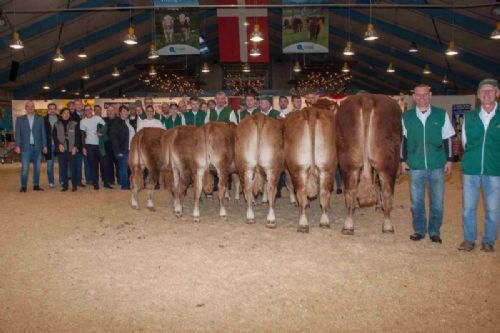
[155,0,200,55]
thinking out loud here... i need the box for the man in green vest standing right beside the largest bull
[401,84,455,243]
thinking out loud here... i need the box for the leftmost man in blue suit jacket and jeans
[14,101,47,192]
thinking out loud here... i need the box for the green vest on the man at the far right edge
[462,106,500,176]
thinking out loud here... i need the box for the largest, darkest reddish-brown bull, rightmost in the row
[336,94,401,235]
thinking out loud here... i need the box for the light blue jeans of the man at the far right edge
[463,175,500,245]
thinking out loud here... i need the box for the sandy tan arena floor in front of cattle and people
[0,164,500,332]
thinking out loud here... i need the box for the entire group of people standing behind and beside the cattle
[15,79,500,252]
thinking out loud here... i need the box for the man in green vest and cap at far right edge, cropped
[458,79,500,252]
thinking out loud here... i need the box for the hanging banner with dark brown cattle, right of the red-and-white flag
[282,0,329,53]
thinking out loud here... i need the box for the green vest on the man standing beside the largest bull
[403,106,446,170]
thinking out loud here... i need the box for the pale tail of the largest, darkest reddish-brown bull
[358,97,378,206]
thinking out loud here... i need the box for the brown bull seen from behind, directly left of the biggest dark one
[283,102,337,232]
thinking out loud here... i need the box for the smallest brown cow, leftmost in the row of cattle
[128,128,166,210]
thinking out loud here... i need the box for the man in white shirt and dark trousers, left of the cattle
[80,105,108,190]
